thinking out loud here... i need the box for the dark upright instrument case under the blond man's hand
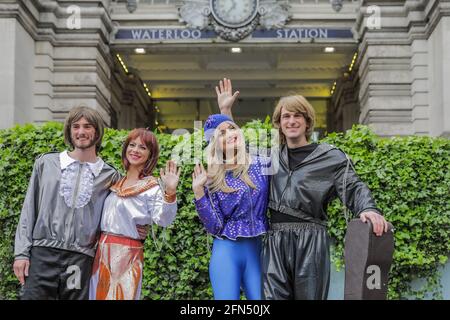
[344,219,394,300]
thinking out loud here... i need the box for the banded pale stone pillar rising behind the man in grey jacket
[33,0,113,125]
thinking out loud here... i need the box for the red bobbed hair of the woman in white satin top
[122,128,159,179]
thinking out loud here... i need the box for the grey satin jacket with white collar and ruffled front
[14,151,120,259]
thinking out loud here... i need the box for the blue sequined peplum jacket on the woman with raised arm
[194,156,270,240]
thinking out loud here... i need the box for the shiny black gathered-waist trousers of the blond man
[261,223,330,300]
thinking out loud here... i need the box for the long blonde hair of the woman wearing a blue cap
[206,121,256,193]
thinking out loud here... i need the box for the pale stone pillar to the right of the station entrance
[356,0,450,136]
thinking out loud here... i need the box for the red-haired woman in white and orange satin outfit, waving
[89,128,181,300]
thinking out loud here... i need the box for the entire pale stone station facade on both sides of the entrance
[0,0,450,136]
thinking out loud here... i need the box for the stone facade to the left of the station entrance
[0,0,151,128]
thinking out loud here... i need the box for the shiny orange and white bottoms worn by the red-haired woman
[89,233,144,300]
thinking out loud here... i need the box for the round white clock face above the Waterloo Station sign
[211,0,259,27]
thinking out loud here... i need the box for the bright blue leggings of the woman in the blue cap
[209,237,261,300]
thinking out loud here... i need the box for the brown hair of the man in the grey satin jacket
[64,106,105,152]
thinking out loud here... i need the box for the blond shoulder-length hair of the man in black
[272,95,316,144]
